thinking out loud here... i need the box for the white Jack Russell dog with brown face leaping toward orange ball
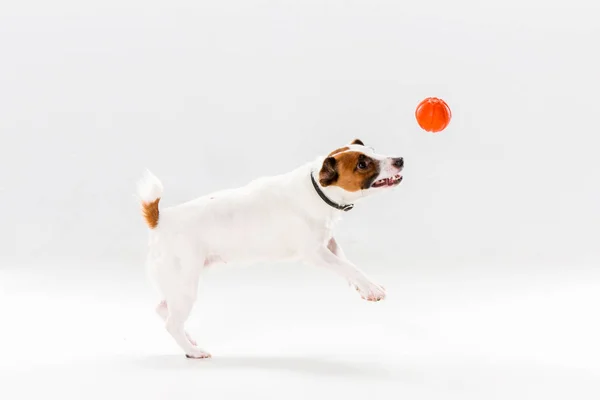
[138,139,404,359]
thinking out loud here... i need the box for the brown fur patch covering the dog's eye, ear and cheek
[319,151,379,192]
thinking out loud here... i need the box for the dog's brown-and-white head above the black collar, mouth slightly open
[318,139,404,200]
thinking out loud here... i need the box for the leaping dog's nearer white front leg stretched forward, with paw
[309,245,385,301]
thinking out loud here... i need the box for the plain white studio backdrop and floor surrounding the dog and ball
[0,0,600,399]
